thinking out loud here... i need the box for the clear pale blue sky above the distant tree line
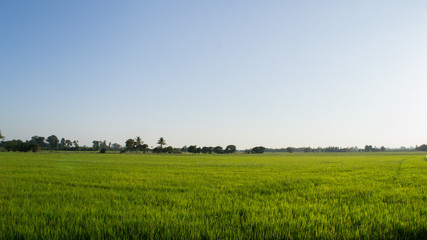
[0,0,427,149]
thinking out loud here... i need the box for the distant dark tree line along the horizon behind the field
[0,131,427,154]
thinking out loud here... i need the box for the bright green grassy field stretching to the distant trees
[0,153,427,239]
